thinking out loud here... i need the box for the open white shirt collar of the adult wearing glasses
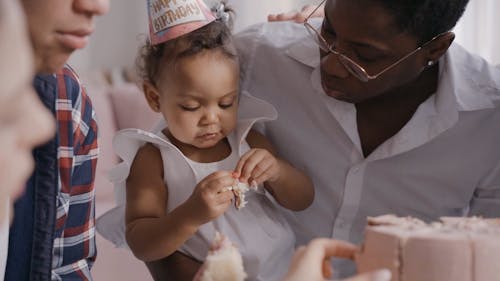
[287,30,500,159]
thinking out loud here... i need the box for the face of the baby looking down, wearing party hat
[159,51,239,151]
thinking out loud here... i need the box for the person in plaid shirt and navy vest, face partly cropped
[5,0,109,281]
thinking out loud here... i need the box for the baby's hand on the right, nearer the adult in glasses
[235,148,280,185]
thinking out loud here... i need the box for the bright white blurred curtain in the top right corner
[455,0,500,64]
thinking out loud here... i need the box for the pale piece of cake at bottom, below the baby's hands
[194,232,247,281]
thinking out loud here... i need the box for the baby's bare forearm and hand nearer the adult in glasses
[236,130,314,211]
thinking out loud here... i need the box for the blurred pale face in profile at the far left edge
[0,0,55,221]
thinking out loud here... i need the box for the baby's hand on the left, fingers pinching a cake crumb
[186,171,236,225]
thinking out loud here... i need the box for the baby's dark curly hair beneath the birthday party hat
[136,0,237,84]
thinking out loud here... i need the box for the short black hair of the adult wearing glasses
[376,0,469,43]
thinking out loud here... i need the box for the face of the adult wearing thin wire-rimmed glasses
[321,0,425,103]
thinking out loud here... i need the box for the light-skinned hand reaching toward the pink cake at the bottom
[283,238,391,281]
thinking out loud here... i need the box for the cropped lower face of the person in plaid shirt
[21,0,109,73]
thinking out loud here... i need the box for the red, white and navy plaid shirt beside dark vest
[52,64,98,280]
